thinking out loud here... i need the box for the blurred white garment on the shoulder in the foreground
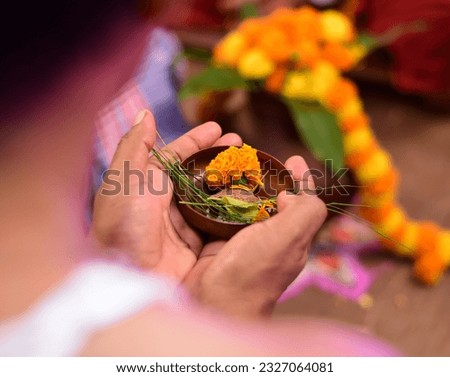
[0,261,180,356]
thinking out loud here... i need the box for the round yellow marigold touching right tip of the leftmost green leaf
[237,48,275,80]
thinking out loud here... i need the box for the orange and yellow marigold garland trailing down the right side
[209,6,450,284]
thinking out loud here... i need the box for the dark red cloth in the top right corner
[360,0,450,93]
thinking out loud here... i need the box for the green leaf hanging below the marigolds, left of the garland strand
[285,99,344,171]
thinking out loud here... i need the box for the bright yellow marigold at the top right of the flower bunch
[320,10,355,42]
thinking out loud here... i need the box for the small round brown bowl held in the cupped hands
[175,146,294,239]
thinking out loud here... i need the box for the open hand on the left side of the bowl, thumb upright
[92,111,242,281]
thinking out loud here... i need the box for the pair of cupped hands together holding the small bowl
[92,111,326,316]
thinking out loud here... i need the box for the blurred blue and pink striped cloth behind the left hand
[89,29,188,212]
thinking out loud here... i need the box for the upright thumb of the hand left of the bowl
[111,110,156,171]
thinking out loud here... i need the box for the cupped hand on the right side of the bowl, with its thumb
[184,156,327,317]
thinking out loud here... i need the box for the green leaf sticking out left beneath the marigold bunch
[178,67,247,100]
